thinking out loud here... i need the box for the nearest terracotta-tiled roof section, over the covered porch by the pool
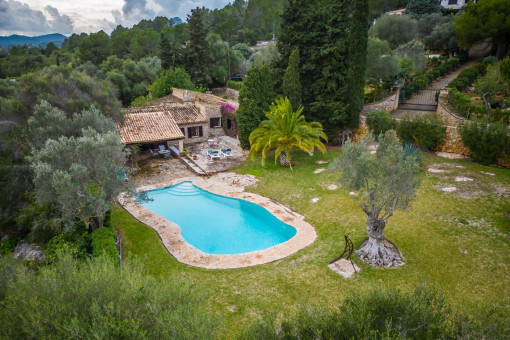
[118,107,184,144]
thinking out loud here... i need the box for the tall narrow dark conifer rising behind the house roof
[188,7,212,86]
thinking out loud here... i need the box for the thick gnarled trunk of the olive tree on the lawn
[356,209,404,267]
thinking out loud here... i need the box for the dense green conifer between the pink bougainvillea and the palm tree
[236,65,275,150]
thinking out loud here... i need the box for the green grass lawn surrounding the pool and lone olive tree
[112,151,510,338]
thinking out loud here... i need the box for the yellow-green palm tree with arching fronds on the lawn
[250,97,327,169]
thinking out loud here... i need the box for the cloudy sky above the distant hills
[0,0,230,36]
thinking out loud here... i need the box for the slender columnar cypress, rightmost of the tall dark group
[346,0,369,128]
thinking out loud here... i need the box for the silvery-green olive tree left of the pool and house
[29,129,129,230]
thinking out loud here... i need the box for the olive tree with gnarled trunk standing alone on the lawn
[332,130,421,267]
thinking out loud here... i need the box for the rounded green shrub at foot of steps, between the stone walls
[397,115,446,150]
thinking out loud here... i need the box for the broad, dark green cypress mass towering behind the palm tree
[275,0,351,140]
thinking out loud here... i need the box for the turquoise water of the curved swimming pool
[141,182,296,255]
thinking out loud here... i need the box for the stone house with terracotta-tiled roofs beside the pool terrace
[118,89,237,156]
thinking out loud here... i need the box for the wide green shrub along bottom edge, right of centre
[241,285,472,339]
